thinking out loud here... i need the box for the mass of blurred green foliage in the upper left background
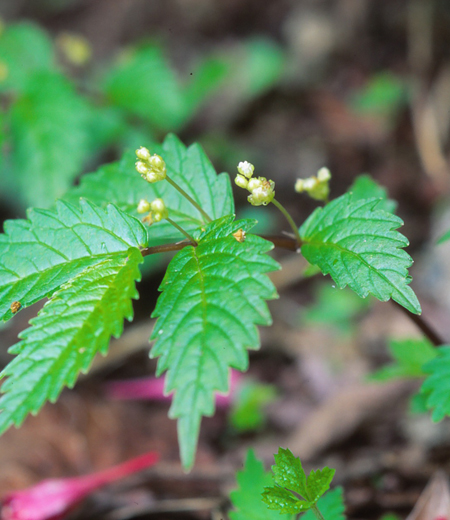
[0,23,284,207]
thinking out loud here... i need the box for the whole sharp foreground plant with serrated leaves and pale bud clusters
[0,131,426,468]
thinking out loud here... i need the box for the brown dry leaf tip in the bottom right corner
[406,471,450,520]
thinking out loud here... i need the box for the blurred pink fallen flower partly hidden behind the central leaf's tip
[106,370,242,408]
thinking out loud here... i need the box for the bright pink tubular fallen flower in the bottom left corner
[1,452,159,520]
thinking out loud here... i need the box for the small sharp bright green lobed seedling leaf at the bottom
[263,448,335,514]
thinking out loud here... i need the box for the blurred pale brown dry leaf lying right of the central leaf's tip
[285,381,411,461]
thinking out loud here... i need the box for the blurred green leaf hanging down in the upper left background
[9,72,90,207]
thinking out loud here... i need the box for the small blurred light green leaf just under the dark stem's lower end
[370,338,438,381]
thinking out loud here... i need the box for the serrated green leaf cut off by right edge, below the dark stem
[420,346,450,422]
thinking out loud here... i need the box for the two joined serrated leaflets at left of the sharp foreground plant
[0,202,146,432]
